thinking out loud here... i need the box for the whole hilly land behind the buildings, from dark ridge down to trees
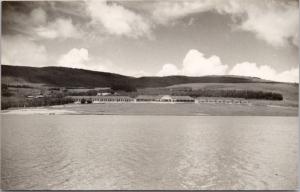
[1,65,298,109]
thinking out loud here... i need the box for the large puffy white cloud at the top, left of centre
[85,0,151,38]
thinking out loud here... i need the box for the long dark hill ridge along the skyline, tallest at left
[1,65,278,88]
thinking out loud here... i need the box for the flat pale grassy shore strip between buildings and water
[1,103,298,116]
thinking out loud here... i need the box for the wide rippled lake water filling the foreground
[1,115,298,189]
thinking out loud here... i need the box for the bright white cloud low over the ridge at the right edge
[228,62,299,82]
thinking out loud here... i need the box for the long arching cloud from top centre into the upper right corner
[152,0,299,47]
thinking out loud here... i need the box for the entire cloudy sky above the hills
[1,0,299,82]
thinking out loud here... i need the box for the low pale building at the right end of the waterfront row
[196,97,248,104]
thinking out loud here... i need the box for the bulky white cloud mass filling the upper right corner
[233,1,299,47]
